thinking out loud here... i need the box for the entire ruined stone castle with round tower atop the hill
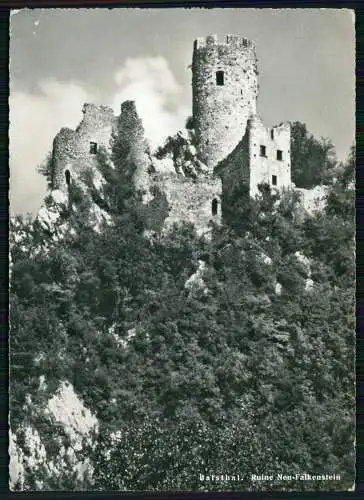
[51,35,291,232]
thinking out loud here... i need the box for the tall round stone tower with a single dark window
[192,35,258,173]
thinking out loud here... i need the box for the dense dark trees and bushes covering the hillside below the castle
[10,124,355,490]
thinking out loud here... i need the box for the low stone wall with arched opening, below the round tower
[148,173,221,234]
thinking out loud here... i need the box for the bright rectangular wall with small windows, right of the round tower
[247,116,291,197]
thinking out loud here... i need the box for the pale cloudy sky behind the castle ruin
[10,8,355,213]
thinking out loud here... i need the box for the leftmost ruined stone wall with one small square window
[52,104,115,190]
